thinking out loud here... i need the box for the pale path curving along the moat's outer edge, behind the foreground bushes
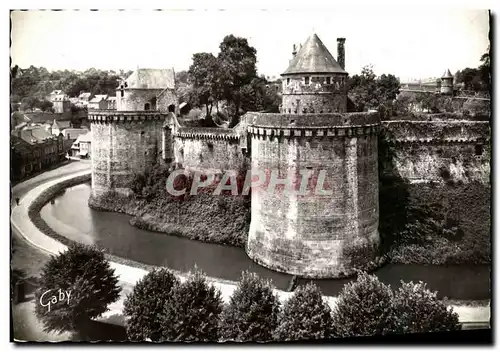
[12,172,490,330]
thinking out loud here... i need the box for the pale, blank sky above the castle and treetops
[11,9,489,80]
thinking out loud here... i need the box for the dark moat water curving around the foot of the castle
[41,184,491,300]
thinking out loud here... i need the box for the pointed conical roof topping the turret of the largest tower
[282,34,347,75]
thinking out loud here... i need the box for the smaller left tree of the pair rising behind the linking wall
[188,53,219,119]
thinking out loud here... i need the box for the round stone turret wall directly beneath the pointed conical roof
[281,74,347,114]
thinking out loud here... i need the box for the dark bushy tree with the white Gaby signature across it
[35,244,121,335]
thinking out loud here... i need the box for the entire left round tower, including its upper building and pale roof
[88,69,176,197]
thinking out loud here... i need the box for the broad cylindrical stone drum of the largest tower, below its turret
[247,113,379,278]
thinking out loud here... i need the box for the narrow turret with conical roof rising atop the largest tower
[281,34,347,114]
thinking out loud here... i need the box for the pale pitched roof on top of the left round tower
[125,68,175,89]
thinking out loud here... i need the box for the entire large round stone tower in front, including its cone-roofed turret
[246,35,380,278]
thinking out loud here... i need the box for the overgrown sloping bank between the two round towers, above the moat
[88,187,250,248]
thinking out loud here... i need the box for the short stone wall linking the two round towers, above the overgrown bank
[174,127,247,174]
